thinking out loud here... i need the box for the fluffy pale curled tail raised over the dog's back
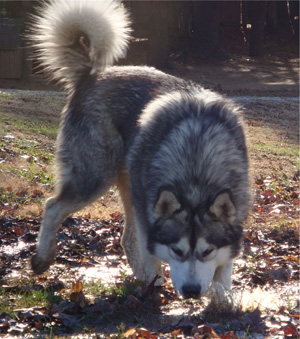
[30,0,130,90]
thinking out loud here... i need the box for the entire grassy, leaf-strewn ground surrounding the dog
[0,45,300,339]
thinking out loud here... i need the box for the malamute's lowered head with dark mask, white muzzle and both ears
[149,190,242,298]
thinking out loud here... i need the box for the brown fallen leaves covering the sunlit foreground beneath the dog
[0,183,300,339]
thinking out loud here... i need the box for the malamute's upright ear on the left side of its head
[154,190,180,219]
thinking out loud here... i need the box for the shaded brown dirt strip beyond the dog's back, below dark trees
[175,56,299,96]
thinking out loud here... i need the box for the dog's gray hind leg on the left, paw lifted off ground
[31,118,124,274]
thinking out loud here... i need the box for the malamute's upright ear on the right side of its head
[209,192,235,224]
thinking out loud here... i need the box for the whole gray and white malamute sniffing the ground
[32,0,249,298]
